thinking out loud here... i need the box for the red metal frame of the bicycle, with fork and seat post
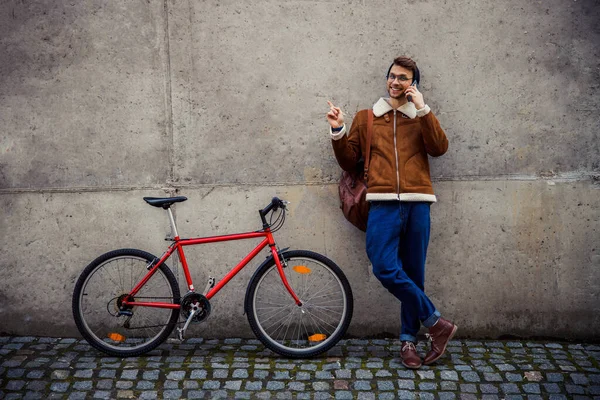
[122,208,302,309]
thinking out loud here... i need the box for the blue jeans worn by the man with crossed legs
[367,201,440,343]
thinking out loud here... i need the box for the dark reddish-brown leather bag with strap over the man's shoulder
[339,110,373,232]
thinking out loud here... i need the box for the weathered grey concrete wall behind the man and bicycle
[0,0,600,339]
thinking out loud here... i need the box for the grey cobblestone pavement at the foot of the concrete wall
[0,337,600,399]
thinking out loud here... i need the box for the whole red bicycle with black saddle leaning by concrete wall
[73,196,353,358]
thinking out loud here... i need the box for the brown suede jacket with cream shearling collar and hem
[331,98,448,203]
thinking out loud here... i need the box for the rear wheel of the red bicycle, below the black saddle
[72,249,180,357]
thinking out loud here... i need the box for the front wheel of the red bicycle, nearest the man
[244,250,354,358]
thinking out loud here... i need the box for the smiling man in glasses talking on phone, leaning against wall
[327,57,457,369]
